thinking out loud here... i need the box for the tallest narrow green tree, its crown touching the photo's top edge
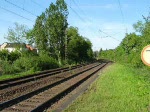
[46,0,68,63]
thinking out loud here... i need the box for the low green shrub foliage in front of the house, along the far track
[0,50,59,74]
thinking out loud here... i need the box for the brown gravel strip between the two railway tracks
[0,63,96,103]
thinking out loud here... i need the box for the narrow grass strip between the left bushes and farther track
[0,70,37,81]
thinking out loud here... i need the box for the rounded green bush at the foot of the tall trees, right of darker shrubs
[14,55,59,72]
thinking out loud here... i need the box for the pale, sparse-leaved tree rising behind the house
[4,23,28,43]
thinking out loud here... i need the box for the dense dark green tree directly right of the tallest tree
[67,27,93,63]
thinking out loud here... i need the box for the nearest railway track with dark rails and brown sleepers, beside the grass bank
[0,63,107,112]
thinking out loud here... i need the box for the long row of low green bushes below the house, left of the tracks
[0,55,59,74]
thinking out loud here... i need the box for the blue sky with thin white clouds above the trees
[0,0,150,50]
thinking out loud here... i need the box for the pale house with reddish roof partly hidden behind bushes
[0,42,37,52]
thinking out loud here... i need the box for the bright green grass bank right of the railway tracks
[65,64,150,112]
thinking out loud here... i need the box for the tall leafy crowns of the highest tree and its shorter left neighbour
[33,0,68,63]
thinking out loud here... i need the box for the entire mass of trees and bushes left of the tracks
[0,0,93,78]
